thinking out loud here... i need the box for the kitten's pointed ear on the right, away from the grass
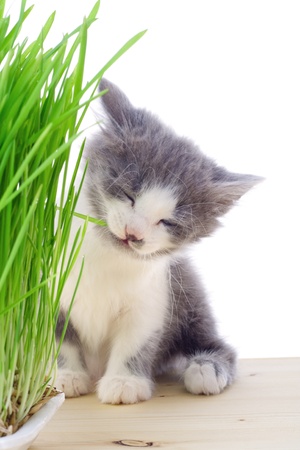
[211,167,264,216]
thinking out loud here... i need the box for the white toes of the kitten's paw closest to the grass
[54,369,91,397]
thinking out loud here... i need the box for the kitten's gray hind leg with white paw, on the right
[171,260,236,395]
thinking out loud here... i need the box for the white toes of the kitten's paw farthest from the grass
[184,361,229,395]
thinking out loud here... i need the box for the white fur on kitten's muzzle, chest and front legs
[58,188,175,403]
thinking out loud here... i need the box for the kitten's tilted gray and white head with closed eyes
[86,79,260,257]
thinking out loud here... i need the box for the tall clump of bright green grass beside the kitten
[0,0,144,436]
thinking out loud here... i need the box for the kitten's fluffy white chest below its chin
[62,229,168,354]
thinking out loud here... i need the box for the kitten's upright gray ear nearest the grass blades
[99,78,134,127]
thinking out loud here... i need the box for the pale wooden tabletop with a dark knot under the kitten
[31,358,300,450]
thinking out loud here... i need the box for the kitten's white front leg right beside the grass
[54,314,92,397]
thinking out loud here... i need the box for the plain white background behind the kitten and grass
[7,0,300,357]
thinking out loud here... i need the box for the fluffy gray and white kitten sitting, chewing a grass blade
[56,79,259,403]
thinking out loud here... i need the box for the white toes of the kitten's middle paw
[97,375,153,404]
